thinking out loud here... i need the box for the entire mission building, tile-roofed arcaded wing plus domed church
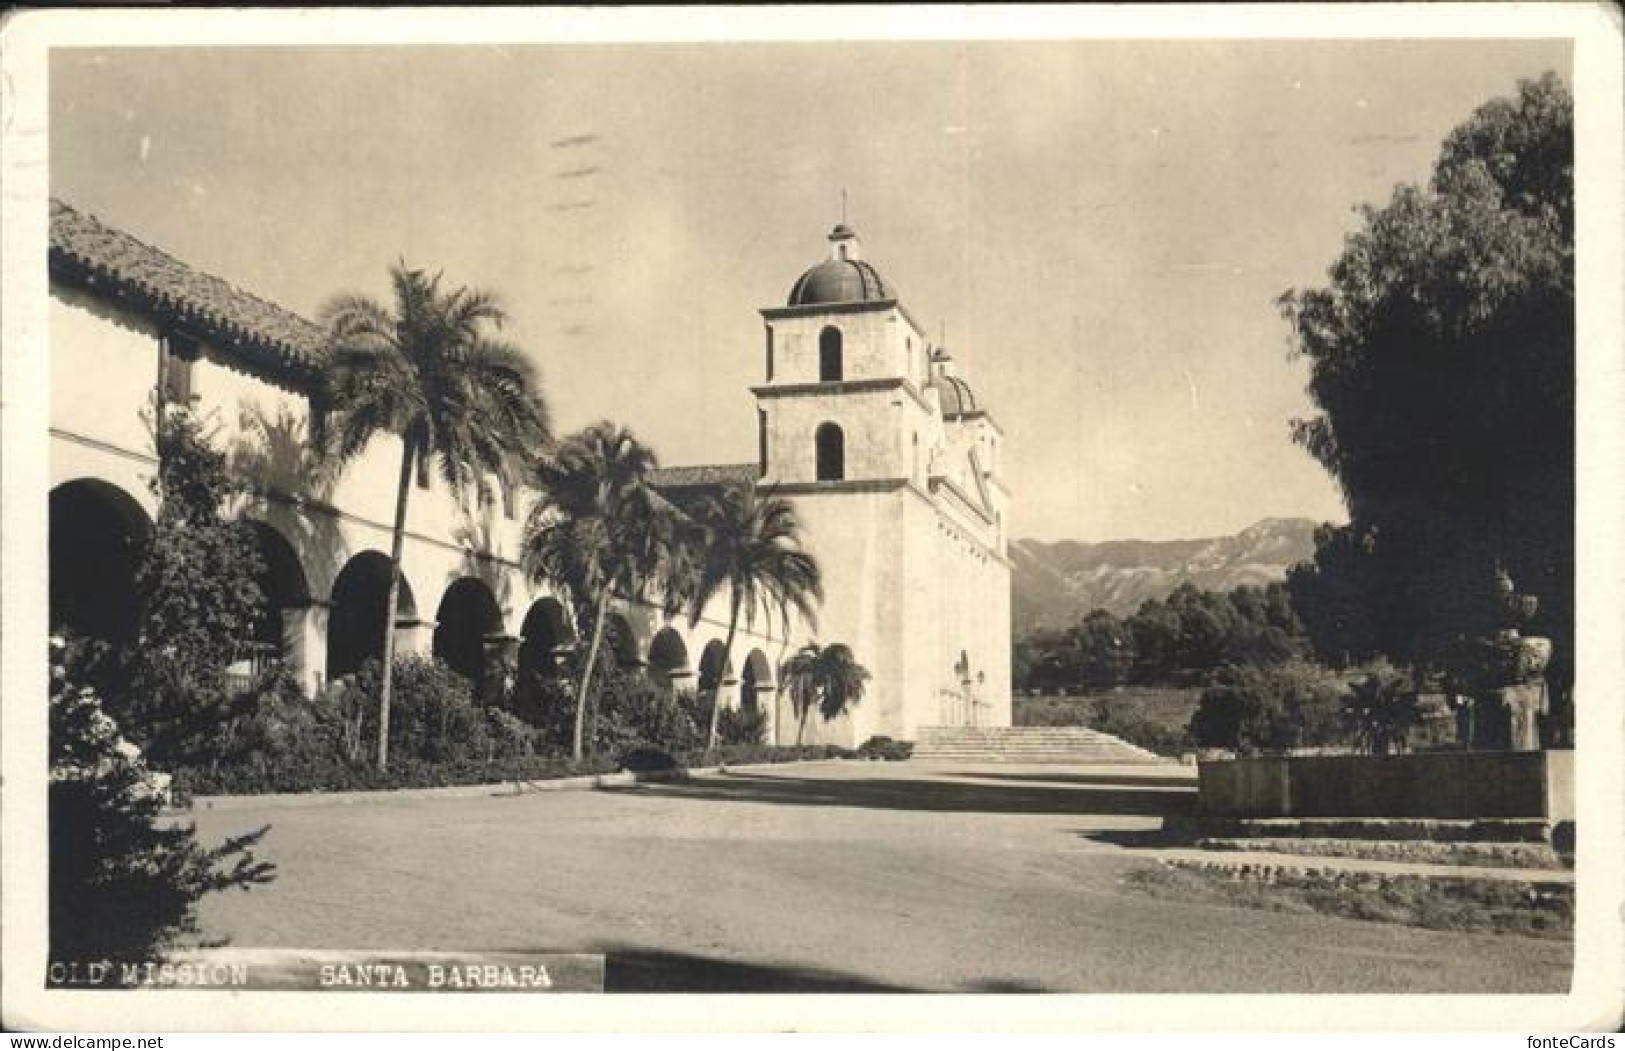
[47,201,1011,747]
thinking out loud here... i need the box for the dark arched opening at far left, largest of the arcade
[49,478,153,643]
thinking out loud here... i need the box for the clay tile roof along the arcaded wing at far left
[50,198,323,375]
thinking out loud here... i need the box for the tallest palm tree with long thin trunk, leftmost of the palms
[322,262,551,770]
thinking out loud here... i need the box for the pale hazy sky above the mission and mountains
[49,41,1570,541]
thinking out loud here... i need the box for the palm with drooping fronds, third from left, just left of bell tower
[683,482,824,755]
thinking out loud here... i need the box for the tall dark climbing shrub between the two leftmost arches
[109,408,267,763]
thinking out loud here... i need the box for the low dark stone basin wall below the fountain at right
[1198,752,1575,822]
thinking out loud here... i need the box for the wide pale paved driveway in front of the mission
[198,763,1570,993]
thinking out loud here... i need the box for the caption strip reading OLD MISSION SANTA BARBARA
[46,949,605,993]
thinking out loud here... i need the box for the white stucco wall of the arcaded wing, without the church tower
[49,286,785,701]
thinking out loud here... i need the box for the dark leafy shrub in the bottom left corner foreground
[49,638,275,960]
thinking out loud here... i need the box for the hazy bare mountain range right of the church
[1009,518,1316,637]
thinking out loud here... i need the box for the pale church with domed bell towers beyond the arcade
[752,226,1011,741]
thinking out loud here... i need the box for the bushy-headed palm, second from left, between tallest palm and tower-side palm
[520,421,678,762]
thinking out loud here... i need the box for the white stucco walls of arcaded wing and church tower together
[49,222,1011,747]
